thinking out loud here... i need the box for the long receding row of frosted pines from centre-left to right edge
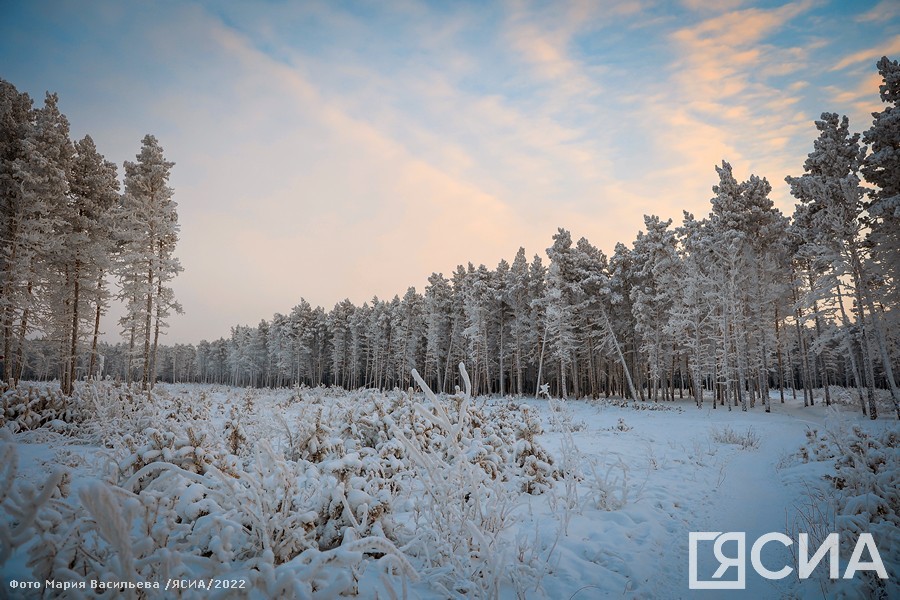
[7,57,900,418]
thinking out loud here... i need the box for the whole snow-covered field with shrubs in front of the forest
[0,372,900,599]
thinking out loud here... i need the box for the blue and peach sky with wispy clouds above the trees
[0,0,900,343]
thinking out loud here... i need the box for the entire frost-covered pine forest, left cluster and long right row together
[0,57,900,419]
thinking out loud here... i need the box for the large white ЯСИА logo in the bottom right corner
[688,531,888,590]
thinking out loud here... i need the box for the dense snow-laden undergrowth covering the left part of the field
[0,368,559,598]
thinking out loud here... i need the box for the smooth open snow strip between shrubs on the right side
[532,402,840,598]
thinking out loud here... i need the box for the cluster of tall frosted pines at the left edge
[0,79,181,394]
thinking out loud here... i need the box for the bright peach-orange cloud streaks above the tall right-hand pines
[624,2,812,220]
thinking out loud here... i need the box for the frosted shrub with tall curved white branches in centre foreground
[388,364,517,597]
